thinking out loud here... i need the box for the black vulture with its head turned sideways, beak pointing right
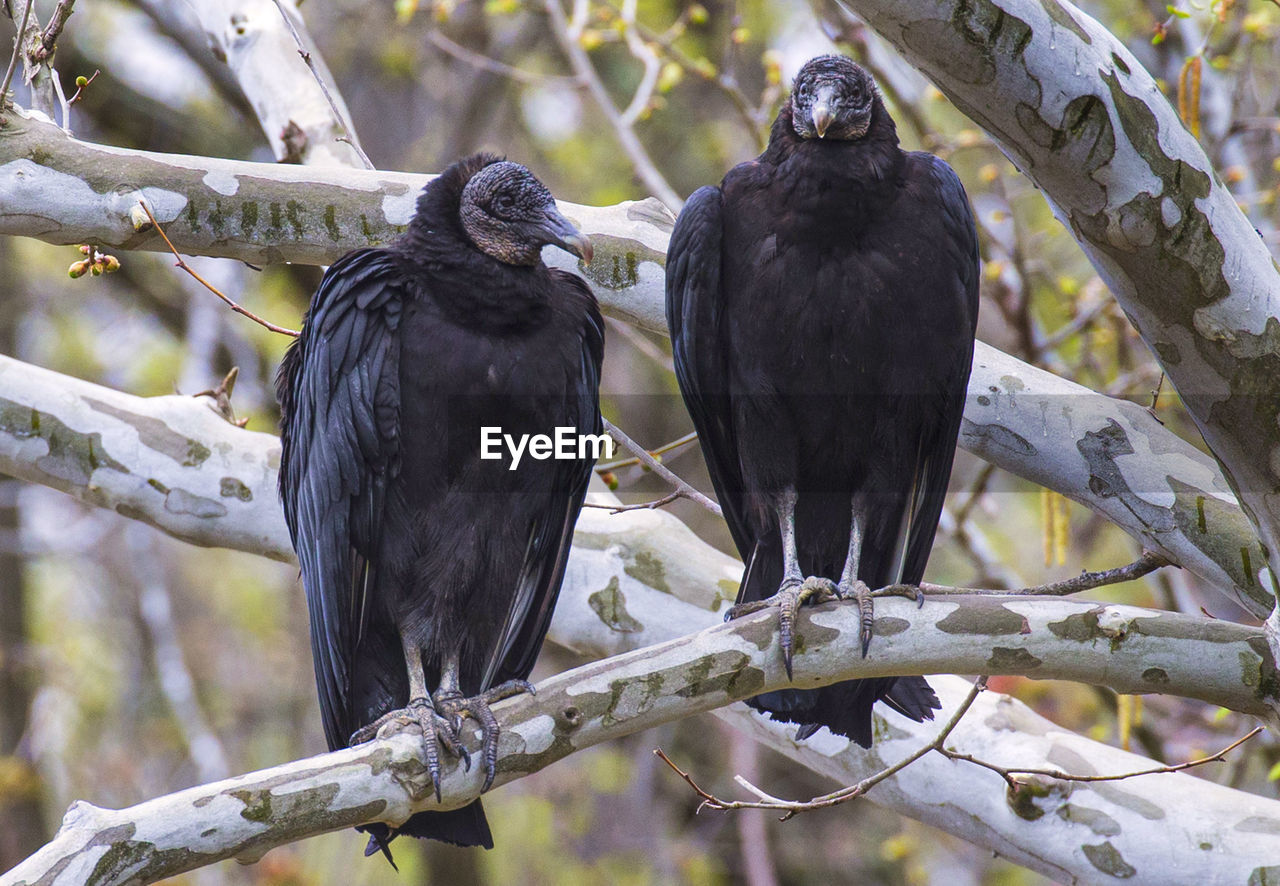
[278,154,604,858]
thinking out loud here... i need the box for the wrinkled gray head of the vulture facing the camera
[791,55,876,141]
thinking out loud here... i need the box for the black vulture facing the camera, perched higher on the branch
[667,55,978,746]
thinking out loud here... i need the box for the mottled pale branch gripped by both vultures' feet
[0,600,1280,886]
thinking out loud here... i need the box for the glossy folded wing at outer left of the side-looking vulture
[276,250,403,749]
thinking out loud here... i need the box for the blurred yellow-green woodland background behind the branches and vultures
[0,0,1280,886]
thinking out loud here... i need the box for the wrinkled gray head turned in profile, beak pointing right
[458,160,591,265]
